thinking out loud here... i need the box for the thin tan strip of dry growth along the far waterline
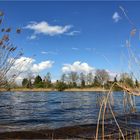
[0,88,108,92]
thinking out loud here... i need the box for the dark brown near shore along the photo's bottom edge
[0,120,140,140]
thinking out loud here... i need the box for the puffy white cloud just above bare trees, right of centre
[62,61,95,73]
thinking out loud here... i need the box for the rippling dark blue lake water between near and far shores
[0,92,140,131]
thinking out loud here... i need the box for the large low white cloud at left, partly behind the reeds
[8,57,54,81]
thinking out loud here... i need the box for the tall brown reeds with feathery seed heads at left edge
[0,11,22,87]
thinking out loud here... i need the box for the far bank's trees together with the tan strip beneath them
[1,70,140,91]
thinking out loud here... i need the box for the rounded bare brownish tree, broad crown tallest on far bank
[95,69,109,85]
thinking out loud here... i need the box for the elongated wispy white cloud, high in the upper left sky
[25,21,72,36]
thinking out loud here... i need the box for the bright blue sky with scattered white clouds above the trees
[0,1,140,79]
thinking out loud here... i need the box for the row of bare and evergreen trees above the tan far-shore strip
[22,69,139,91]
